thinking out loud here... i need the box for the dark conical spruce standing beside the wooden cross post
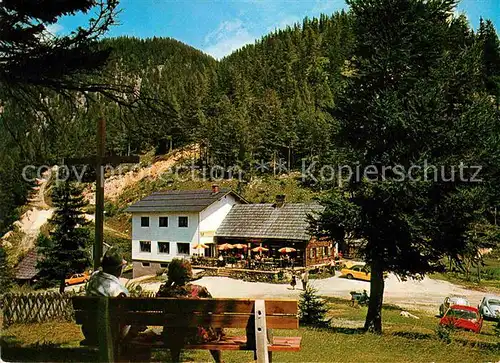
[38,181,90,292]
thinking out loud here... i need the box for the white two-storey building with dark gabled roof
[127,185,246,278]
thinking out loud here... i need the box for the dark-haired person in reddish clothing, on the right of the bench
[156,259,224,363]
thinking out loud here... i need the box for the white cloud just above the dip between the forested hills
[204,19,257,59]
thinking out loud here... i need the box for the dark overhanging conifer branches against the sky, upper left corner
[0,0,118,98]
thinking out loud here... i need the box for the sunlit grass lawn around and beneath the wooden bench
[2,298,500,363]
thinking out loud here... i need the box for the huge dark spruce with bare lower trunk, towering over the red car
[318,0,500,333]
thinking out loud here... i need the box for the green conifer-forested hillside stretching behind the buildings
[0,12,499,236]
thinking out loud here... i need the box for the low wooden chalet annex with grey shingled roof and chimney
[215,196,336,266]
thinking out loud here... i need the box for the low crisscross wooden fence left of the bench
[2,292,74,328]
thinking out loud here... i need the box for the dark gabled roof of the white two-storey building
[126,189,246,213]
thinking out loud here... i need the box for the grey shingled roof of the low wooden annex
[215,203,324,240]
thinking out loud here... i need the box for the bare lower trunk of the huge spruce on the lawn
[364,261,384,334]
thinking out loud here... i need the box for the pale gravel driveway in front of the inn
[136,274,485,314]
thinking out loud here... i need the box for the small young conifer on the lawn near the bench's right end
[299,286,329,327]
